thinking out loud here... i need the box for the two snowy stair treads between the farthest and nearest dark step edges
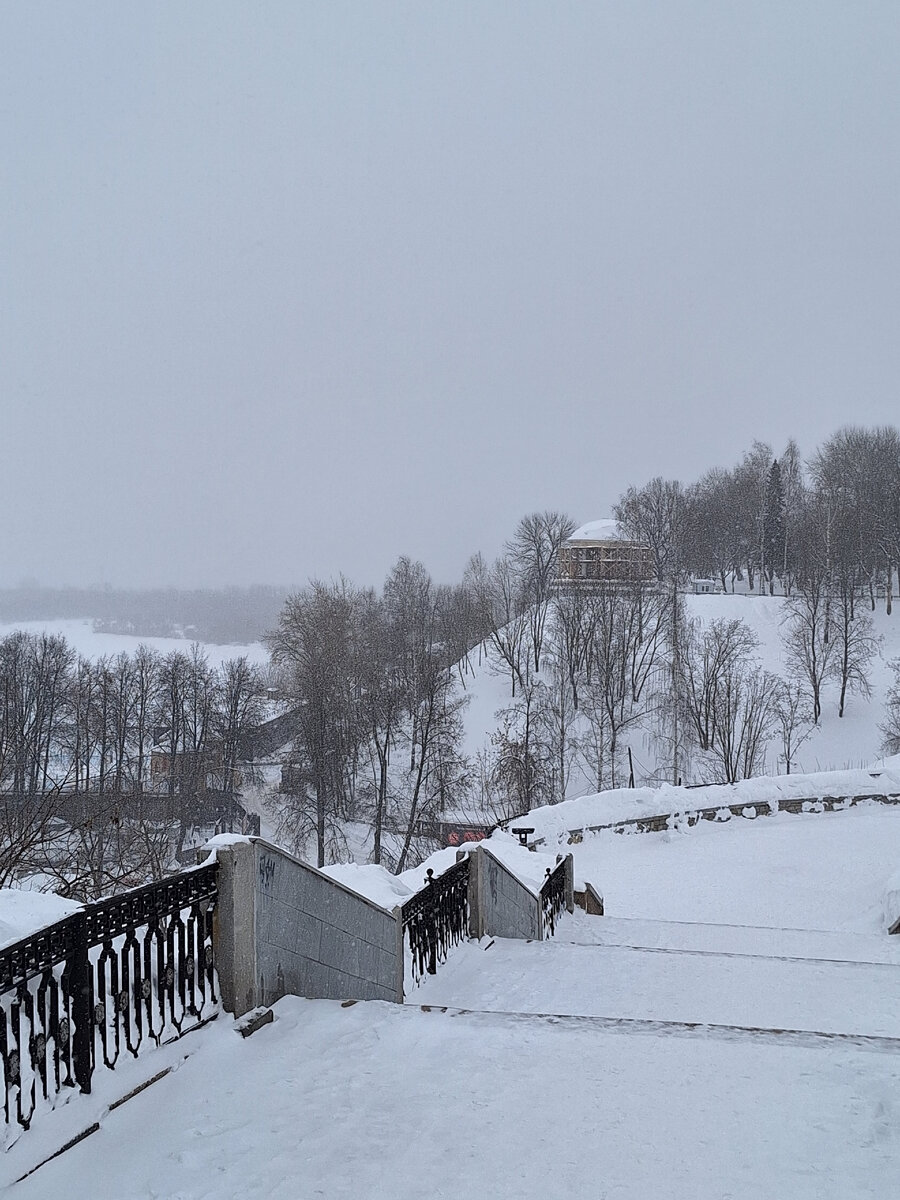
[409,913,900,1046]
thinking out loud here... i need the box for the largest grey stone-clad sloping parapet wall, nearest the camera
[212,838,403,1016]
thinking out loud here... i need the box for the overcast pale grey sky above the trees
[0,0,900,586]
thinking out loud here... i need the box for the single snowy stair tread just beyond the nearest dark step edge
[409,918,900,1038]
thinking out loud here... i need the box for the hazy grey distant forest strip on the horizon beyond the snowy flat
[0,584,288,644]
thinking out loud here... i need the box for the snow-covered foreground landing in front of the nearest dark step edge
[11,993,900,1200]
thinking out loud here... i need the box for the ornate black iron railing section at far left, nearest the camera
[0,863,218,1144]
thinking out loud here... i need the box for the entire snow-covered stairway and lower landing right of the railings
[7,792,900,1200]
